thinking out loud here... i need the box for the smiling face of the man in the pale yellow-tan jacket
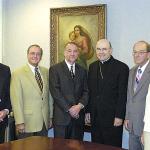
[27,46,42,66]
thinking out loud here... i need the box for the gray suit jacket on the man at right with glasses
[126,63,150,136]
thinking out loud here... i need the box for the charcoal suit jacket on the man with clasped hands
[49,61,88,125]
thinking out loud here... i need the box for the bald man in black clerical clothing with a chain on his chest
[86,39,129,147]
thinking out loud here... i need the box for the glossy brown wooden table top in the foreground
[0,136,126,150]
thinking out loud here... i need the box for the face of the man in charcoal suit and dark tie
[64,44,79,64]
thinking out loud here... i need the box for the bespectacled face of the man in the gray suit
[133,42,150,66]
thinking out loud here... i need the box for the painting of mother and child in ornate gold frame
[50,4,106,65]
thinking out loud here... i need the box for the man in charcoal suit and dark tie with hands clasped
[49,42,88,140]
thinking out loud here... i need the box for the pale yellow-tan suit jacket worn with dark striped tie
[10,65,52,132]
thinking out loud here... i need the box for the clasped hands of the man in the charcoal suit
[69,104,81,119]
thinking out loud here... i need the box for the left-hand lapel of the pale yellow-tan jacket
[24,65,42,94]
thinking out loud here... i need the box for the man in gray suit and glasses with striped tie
[125,41,150,150]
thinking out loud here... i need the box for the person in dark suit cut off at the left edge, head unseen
[0,64,11,143]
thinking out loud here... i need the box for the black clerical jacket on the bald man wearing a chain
[88,57,129,127]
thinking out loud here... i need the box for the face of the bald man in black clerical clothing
[96,40,112,61]
